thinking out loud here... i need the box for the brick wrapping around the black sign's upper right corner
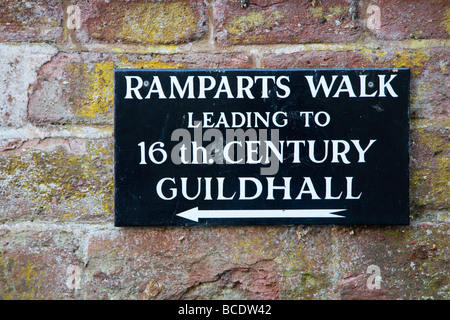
[262,47,450,120]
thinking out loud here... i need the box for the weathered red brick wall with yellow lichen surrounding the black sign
[0,0,450,299]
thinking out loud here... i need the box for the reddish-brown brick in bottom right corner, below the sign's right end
[331,224,450,300]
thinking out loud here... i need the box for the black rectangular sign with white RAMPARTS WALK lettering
[115,69,410,226]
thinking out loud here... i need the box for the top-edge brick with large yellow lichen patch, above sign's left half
[75,0,207,44]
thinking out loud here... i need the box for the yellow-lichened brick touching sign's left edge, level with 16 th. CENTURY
[0,142,114,221]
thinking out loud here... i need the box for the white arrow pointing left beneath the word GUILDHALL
[177,208,347,222]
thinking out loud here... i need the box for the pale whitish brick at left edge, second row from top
[0,44,56,128]
